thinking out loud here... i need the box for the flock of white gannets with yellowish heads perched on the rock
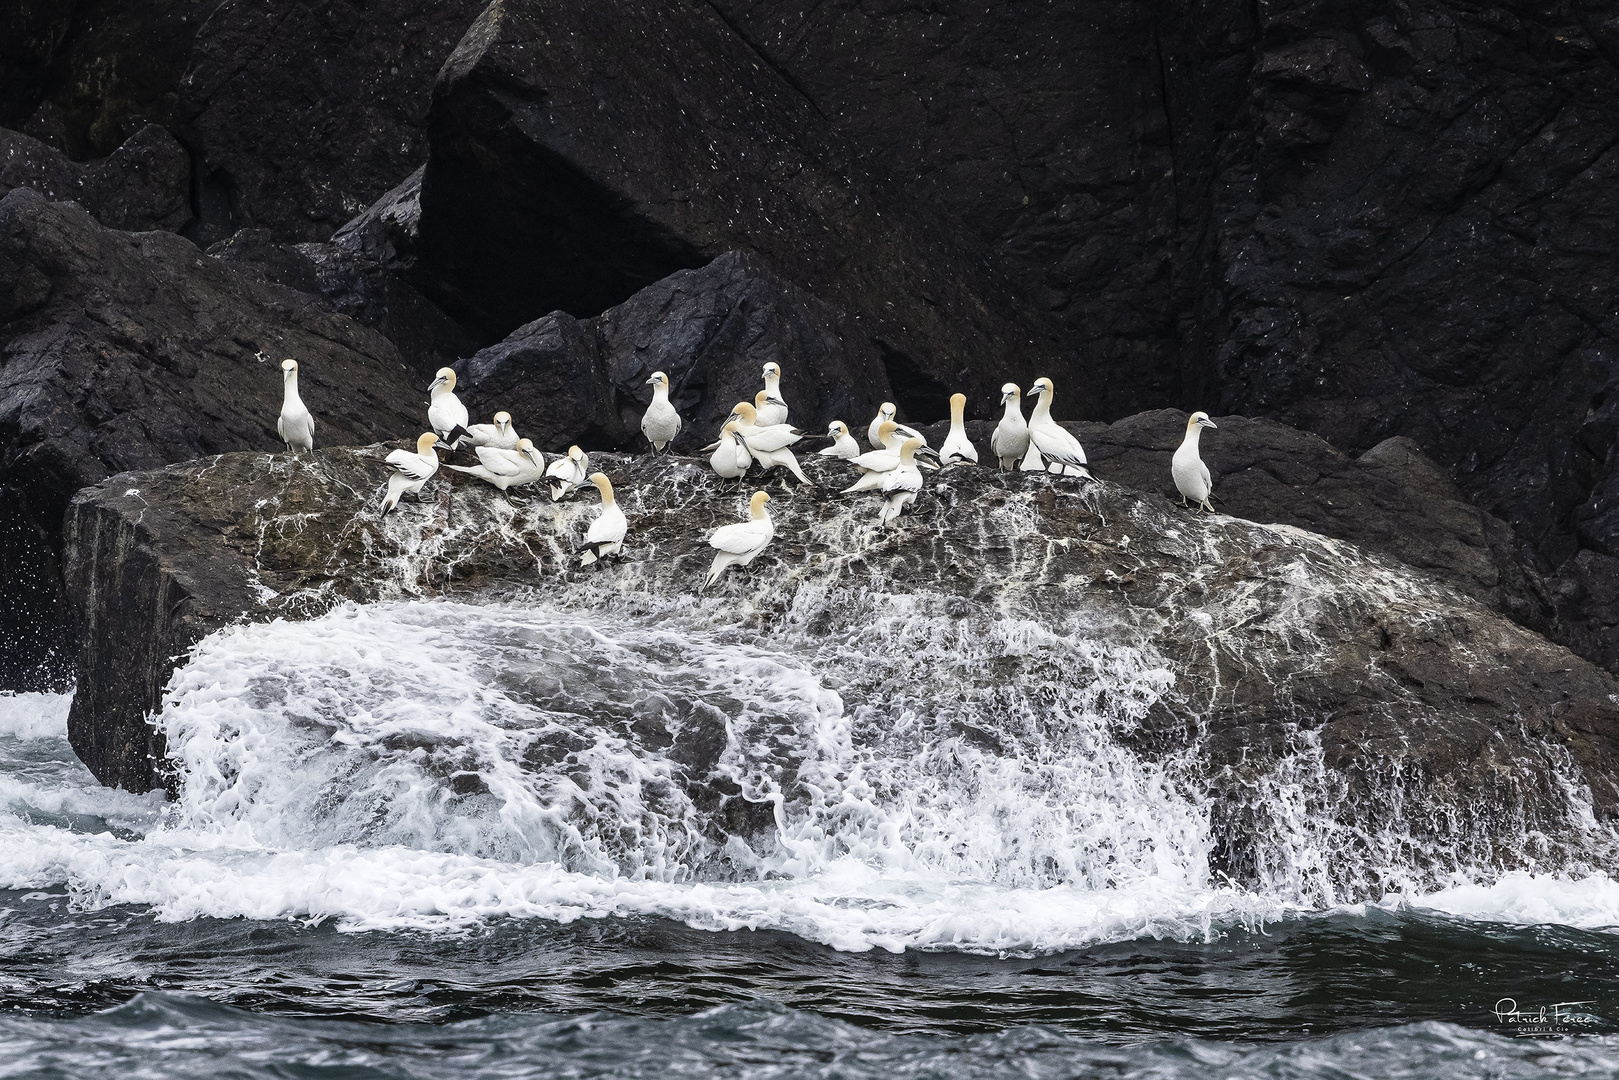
[275,359,1214,588]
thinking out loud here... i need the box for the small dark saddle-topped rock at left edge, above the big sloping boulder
[0,123,191,232]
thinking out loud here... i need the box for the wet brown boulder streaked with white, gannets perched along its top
[68,447,1619,902]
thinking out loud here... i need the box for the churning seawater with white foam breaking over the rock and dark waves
[0,597,1619,1077]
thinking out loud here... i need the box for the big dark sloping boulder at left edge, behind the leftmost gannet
[0,188,424,688]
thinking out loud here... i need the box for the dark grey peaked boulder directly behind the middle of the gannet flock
[461,251,890,450]
